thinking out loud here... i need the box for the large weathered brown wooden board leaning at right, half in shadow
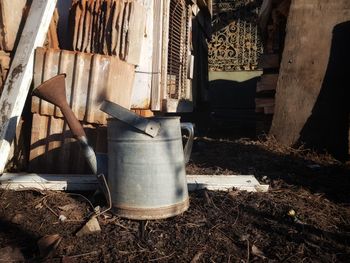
[270,0,350,160]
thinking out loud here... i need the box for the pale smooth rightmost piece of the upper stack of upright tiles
[125,2,146,65]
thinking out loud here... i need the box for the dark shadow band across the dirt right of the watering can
[187,138,350,203]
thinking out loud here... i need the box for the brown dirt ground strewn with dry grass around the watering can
[0,137,350,262]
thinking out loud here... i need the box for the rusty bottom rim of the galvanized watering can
[112,198,190,220]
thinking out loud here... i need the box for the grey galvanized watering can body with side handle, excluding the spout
[107,117,193,220]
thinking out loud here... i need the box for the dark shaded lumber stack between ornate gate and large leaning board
[255,0,291,114]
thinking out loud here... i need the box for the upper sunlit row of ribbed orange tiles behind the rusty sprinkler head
[32,48,135,124]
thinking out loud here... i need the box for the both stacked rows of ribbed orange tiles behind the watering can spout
[29,48,135,174]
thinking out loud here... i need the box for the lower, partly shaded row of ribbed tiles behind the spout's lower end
[29,114,107,174]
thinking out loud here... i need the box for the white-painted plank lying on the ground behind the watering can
[0,173,269,192]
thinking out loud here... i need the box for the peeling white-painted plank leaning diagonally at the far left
[0,0,56,173]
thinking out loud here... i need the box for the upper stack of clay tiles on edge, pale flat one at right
[70,0,146,65]
